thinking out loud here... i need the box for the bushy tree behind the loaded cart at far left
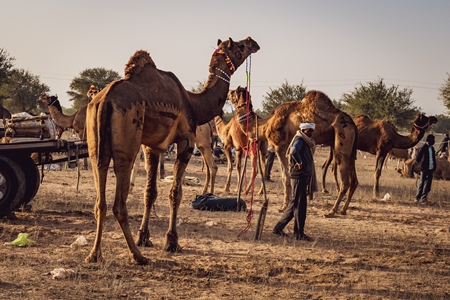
[2,69,50,114]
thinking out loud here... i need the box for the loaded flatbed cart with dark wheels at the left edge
[0,114,88,217]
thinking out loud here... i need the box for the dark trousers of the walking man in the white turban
[274,178,309,236]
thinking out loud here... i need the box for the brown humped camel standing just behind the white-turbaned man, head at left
[228,87,358,217]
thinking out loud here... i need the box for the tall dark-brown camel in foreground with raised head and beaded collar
[86,37,259,265]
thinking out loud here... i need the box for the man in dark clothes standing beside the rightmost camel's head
[416,134,436,202]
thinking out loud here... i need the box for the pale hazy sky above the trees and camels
[0,0,450,115]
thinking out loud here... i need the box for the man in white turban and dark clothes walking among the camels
[273,122,316,241]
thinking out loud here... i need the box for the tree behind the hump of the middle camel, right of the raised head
[262,81,306,115]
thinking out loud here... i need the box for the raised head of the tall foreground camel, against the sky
[214,37,260,75]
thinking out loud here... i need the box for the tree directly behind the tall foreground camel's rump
[67,68,120,109]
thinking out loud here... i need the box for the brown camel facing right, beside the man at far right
[322,114,437,198]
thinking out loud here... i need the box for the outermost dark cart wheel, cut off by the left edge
[0,155,25,217]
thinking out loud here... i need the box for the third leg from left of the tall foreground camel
[136,148,160,247]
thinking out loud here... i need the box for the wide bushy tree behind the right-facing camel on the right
[340,78,419,128]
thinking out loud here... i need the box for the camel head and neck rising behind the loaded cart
[39,93,87,140]
